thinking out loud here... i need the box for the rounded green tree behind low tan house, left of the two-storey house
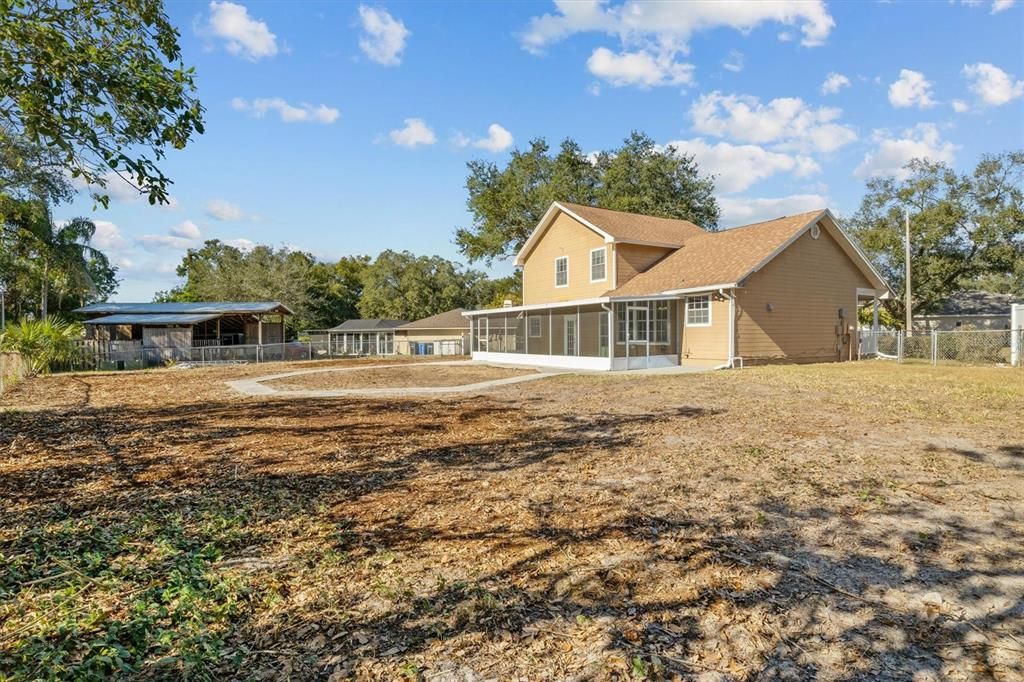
[357,251,493,319]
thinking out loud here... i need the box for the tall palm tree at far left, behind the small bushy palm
[10,197,110,319]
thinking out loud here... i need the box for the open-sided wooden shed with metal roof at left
[74,301,292,348]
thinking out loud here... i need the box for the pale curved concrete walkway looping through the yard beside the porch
[226,360,564,398]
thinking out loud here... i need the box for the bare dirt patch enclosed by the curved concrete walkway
[264,363,537,390]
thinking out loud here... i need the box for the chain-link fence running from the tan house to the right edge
[858,329,1024,368]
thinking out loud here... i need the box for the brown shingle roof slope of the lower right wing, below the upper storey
[607,209,824,296]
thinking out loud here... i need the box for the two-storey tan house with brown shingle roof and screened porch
[465,202,892,370]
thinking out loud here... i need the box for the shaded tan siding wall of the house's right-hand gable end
[736,222,871,363]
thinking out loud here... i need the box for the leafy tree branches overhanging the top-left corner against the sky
[0,0,203,206]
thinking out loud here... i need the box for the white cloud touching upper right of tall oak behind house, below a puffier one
[666,137,821,195]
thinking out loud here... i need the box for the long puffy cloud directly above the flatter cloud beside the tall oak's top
[690,91,857,153]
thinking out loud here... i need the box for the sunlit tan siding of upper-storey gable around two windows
[522,213,613,305]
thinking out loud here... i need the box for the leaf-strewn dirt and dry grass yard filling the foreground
[0,361,1024,681]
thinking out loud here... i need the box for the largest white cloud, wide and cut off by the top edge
[520,0,836,53]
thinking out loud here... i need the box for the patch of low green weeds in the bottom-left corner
[0,501,254,679]
